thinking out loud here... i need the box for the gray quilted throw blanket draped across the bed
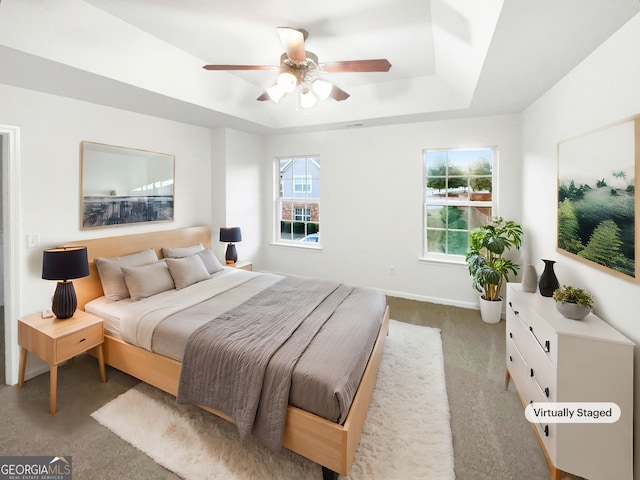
[178,277,353,450]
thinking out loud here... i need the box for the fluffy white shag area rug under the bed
[91,320,455,480]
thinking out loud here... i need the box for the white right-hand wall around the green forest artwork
[522,11,640,479]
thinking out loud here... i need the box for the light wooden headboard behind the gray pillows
[65,226,211,310]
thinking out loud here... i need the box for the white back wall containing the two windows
[257,115,521,308]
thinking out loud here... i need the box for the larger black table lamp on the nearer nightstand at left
[42,247,89,319]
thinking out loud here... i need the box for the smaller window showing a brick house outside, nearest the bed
[276,157,320,242]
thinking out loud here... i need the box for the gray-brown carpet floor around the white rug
[0,298,576,480]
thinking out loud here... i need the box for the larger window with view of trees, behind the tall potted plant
[423,148,497,257]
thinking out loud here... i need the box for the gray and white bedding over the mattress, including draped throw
[107,268,386,452]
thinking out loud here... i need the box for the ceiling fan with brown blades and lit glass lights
[202,27,391,108]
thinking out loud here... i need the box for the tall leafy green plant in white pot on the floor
[465,217,522,323]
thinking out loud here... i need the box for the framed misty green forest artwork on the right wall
[557,116,640,281]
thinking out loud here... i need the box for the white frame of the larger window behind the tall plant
[419,145,499,264]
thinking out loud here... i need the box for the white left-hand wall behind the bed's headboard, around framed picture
[0,85,211,380]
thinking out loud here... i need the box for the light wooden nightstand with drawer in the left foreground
[18,310,107,415]
